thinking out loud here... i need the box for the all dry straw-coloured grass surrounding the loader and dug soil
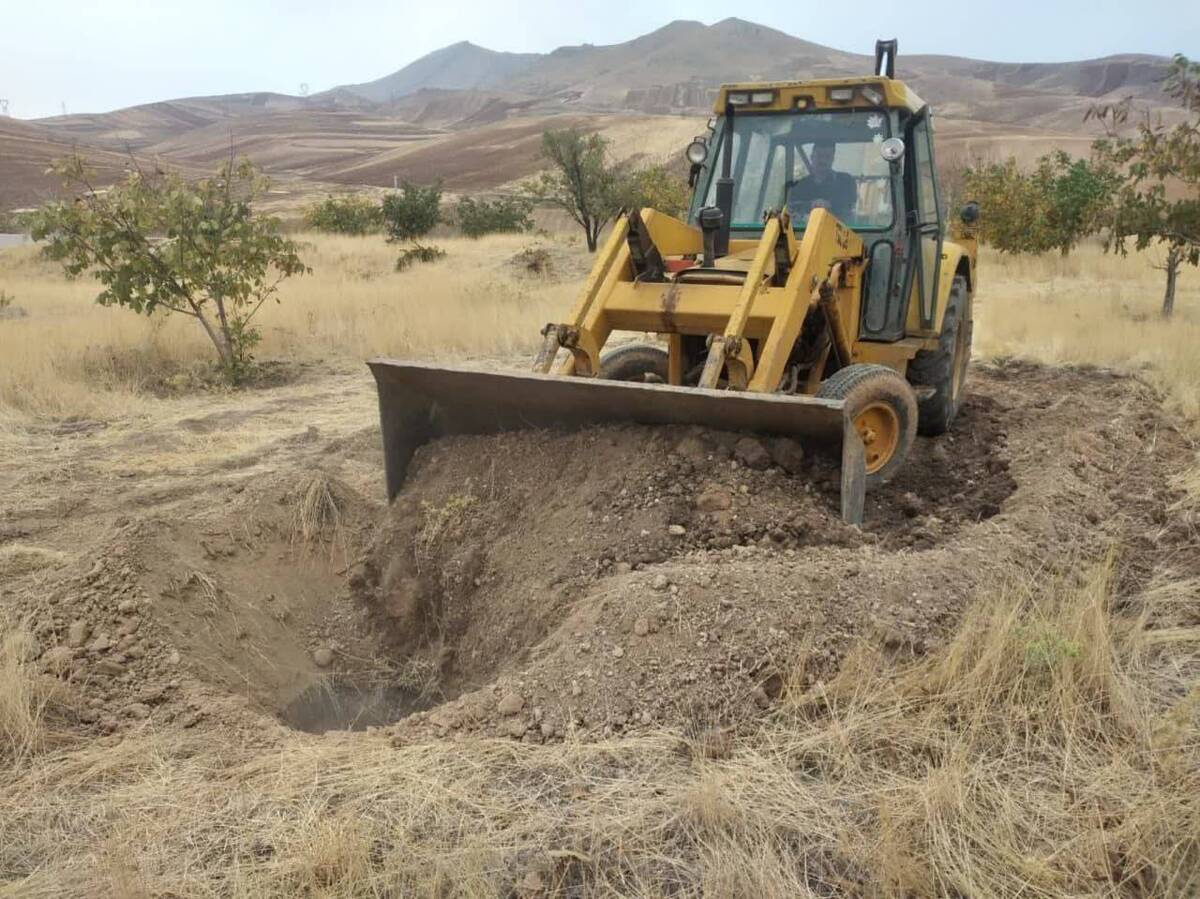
[0,228,1200,899]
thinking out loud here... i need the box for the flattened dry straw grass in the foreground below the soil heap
[0,561,1200,899]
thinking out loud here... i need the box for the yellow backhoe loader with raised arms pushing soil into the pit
[370,41,978,523]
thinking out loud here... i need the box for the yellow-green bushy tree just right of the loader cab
[962,150,1120,256]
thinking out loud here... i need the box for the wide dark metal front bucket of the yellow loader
[368,359,866,525]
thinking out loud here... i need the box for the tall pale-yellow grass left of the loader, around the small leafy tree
[0,235,572,416]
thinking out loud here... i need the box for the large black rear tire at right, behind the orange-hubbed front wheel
[908,275,971,437]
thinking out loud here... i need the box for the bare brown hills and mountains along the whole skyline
[0,18,1175,210]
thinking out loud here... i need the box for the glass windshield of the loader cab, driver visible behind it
[704,109,893,230]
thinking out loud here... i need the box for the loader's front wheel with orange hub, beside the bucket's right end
[817,364,917,490]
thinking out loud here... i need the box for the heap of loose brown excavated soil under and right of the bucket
[350,357,1186,741]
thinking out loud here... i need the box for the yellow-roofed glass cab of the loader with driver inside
[688,41,973,342]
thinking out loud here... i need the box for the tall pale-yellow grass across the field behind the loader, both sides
[0,234,1200,418]
